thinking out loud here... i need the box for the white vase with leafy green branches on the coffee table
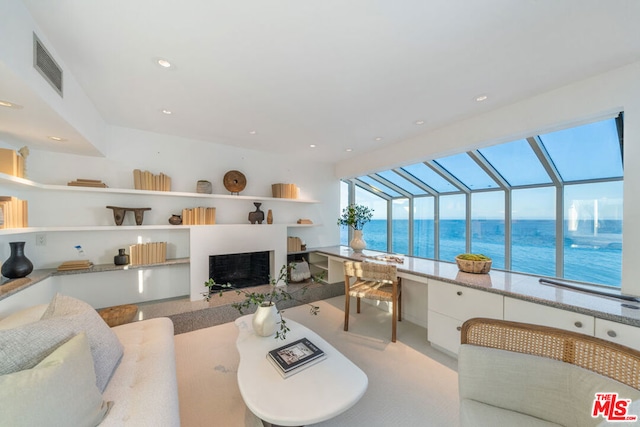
[202,263,322,340]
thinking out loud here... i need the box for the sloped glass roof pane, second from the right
[478,139,551,186]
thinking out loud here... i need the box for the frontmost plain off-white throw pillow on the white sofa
[0,333,111,427]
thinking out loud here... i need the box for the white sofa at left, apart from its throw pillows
[0,296,180,427]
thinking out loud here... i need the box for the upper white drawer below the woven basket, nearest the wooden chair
[428,280,503,320]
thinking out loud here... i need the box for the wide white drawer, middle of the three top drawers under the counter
[504,297,594,335]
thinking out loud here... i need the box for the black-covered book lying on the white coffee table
[267,338,327,378]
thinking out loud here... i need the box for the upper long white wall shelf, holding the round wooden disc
[0,173,319,203]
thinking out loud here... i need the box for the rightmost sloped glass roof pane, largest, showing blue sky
[540,119,623,182]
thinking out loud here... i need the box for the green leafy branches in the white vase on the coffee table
[202,262,324,340]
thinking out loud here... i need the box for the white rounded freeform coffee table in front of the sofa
[235,315,369,426]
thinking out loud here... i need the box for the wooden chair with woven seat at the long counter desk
[344,261,402,342]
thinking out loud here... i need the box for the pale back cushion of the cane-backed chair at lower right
[458,344,640,427]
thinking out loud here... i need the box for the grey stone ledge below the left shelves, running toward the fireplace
[0,258,189,300]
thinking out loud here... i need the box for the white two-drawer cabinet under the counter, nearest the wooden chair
[427,280,503,354]
